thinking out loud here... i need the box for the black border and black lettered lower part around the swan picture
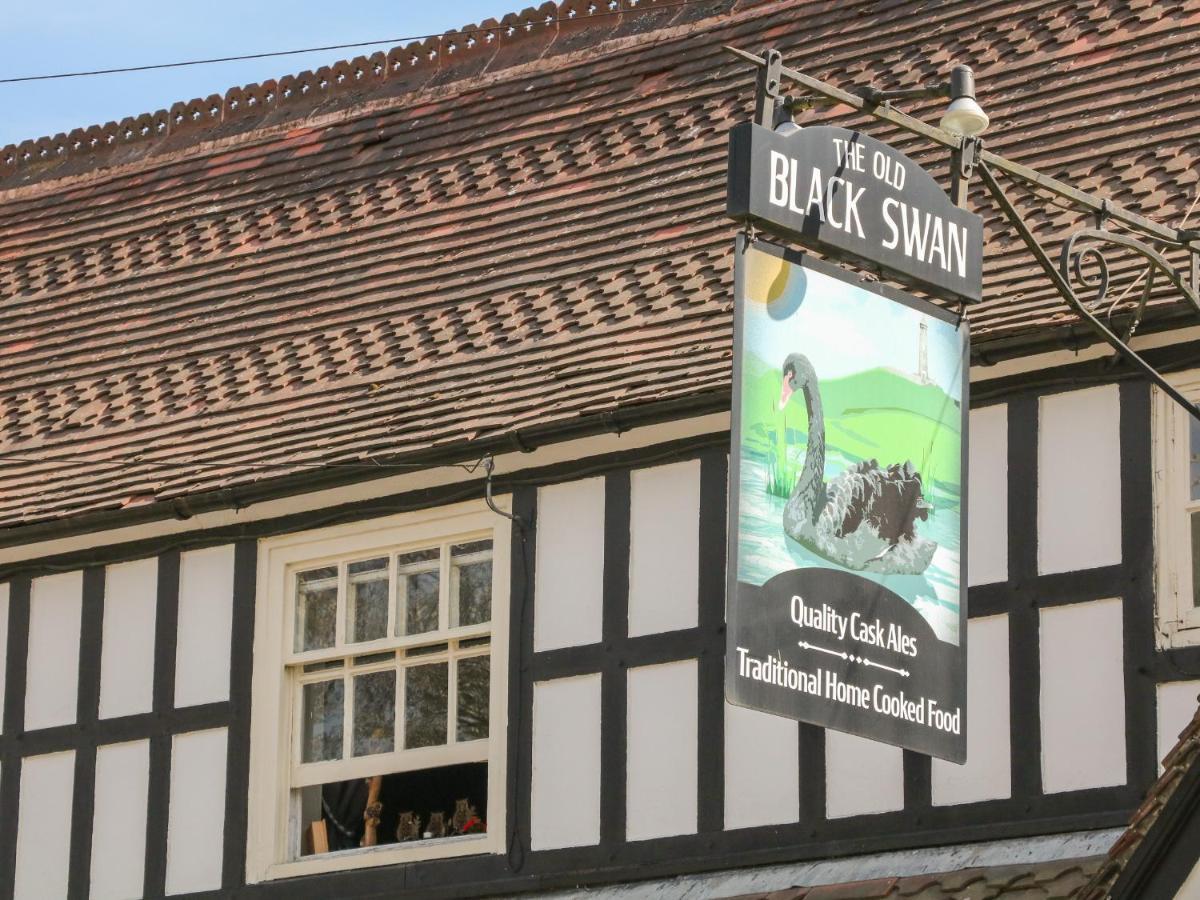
[725,234,970,763]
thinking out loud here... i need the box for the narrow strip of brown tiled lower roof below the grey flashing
[731,857,1103,900]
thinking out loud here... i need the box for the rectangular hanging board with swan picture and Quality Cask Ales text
[726,238,968,762]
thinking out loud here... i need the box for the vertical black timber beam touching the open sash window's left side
[221,539,258,890]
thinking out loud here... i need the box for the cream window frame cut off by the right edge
[1151,370,1200,648]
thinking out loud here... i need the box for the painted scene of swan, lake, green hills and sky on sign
[737,248,962,644]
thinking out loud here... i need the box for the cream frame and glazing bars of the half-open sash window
[246,498,511,883]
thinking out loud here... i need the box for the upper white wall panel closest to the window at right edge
[1036,385,1121,572]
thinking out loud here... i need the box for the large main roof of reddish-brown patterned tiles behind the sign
[0,0,1200,540]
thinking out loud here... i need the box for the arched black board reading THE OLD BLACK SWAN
[727,122,983,301]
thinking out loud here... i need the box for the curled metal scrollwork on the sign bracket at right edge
[1058,228,1200,342]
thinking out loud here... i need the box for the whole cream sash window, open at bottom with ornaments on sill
[247,504,509,881]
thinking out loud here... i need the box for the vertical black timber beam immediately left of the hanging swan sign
[696,448,728,833]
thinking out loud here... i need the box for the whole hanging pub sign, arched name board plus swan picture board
[726,124,983,762]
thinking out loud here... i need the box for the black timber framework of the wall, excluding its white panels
[0,366,1200,900]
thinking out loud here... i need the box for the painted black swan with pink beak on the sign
[779,353,937,575]
